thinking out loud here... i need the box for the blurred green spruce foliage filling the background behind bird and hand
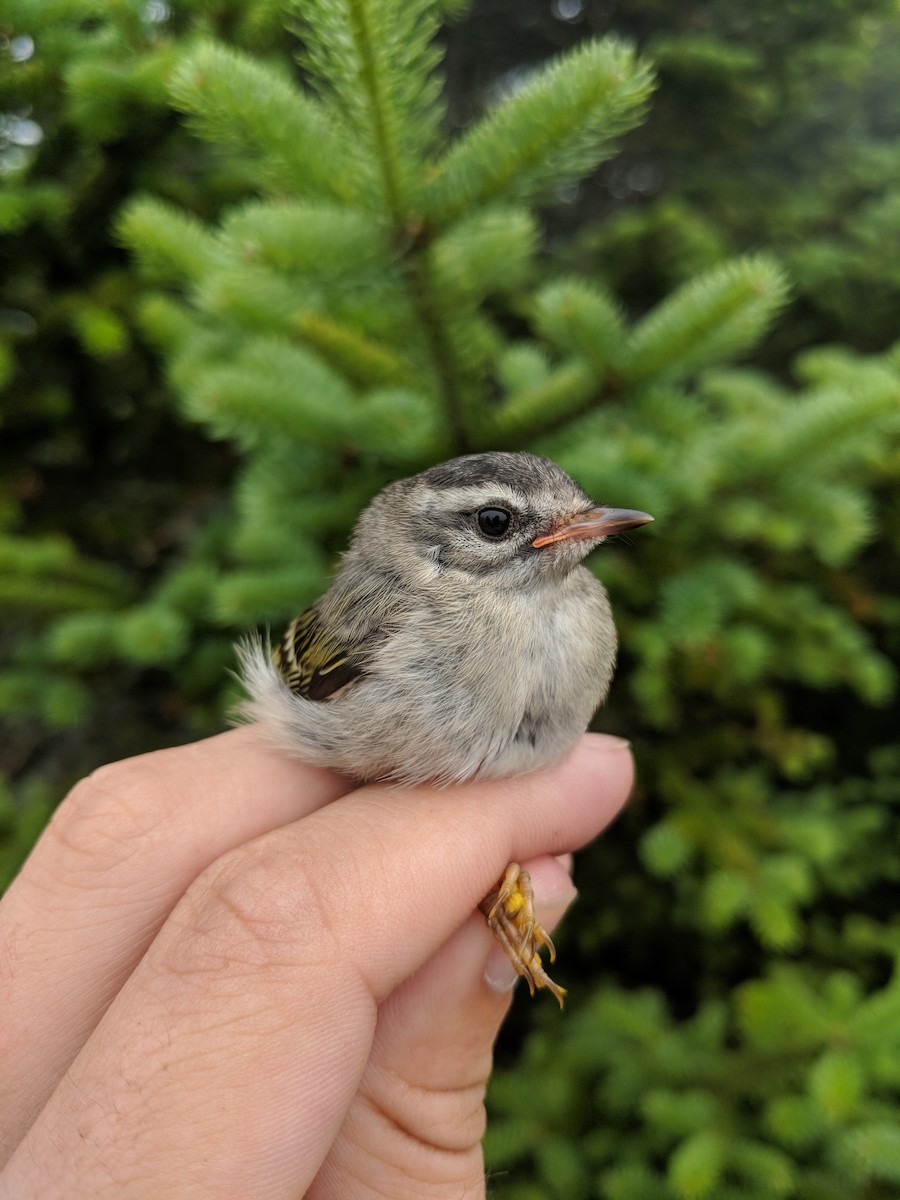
[0,0,900,1200]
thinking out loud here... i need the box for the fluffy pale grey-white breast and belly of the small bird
[240,568,616,782]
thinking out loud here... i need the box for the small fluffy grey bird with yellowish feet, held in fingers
[238,450,653,1006]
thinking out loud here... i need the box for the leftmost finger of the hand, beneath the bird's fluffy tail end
[0,726,353,1162]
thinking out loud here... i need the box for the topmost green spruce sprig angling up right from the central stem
[424,38,652,227]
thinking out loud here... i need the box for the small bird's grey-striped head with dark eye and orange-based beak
[352,451,653,588]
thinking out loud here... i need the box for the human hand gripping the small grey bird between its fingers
[0,728,632,1200]
